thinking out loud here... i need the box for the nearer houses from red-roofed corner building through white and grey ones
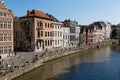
[14,9,80,52]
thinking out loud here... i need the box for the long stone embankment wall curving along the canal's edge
[0,40,118,80]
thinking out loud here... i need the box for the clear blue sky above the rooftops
[5,0,120,25]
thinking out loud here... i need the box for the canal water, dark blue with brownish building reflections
[14,46,120,80]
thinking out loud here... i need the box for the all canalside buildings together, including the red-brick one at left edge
[0,0,111,57]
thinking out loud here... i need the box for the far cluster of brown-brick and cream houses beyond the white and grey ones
[81,21,111,44]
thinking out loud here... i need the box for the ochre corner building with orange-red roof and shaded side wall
[14,10,52,52]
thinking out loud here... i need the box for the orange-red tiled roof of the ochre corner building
[20,9,52,20]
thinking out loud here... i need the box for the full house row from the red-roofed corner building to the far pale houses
[14,9,111,52]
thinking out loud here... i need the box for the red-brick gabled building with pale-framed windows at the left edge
[0,1,13,58]
